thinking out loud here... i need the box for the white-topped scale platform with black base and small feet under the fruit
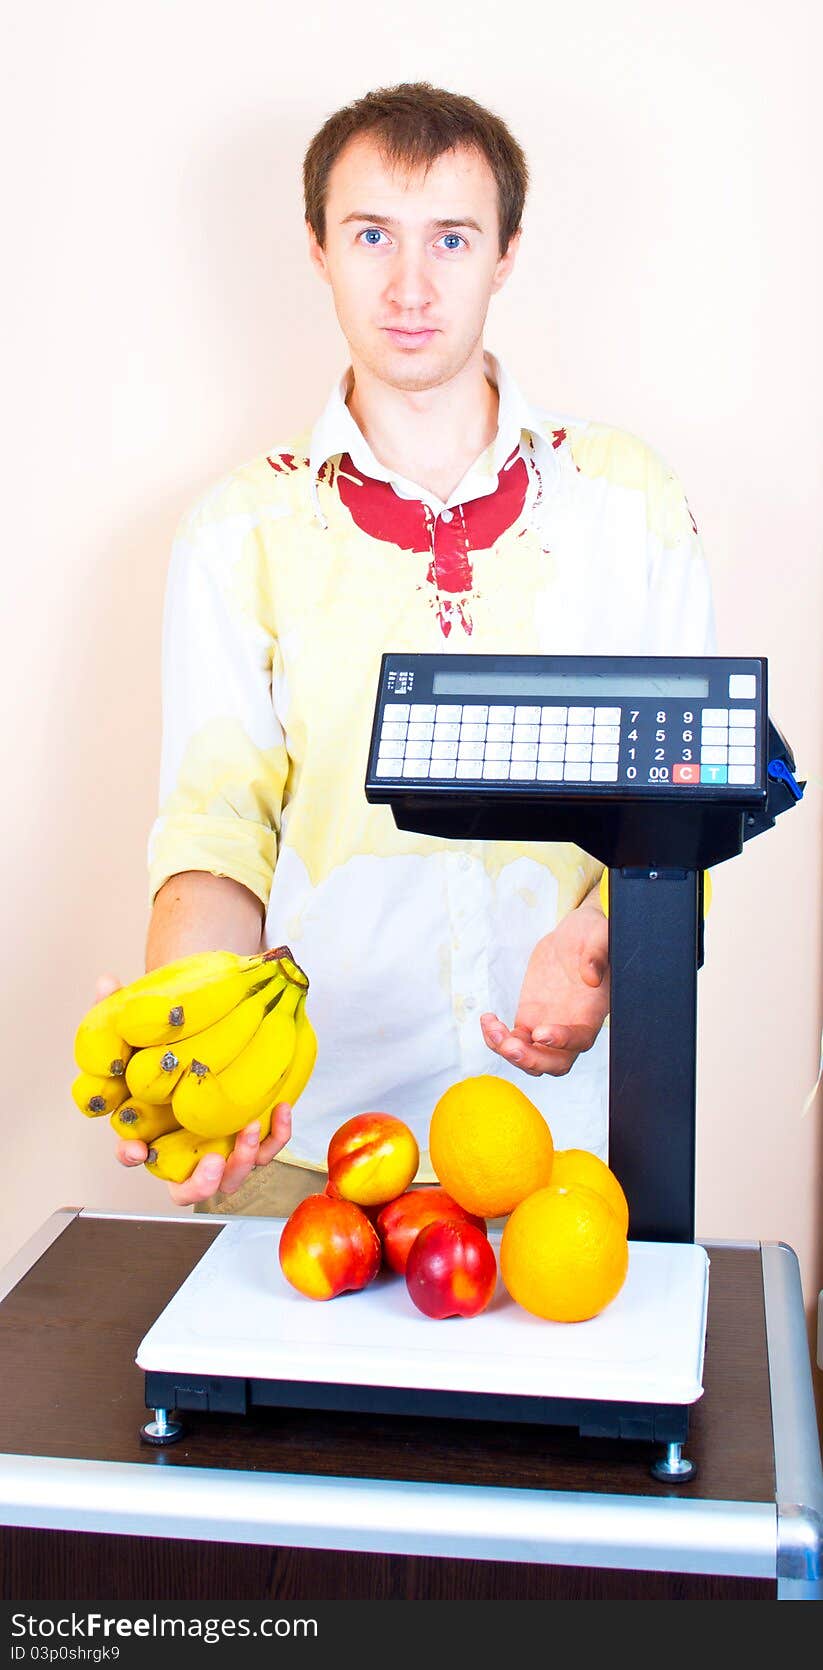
[137,1217,708,1483]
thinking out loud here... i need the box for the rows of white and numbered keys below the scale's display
[376,691,756,787]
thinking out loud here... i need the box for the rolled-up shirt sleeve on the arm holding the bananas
[149,496,289,907]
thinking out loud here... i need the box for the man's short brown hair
[302,82,529,256]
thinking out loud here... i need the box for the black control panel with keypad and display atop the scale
[366,655,768,803]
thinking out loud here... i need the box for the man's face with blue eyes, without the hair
[309,137,519,391]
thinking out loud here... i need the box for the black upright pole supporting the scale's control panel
[609,868,703,1241]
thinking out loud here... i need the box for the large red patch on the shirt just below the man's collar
[332,448,529,638]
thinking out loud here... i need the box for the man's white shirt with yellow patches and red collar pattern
[149,354,714,1181]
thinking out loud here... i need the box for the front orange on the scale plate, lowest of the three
[501,1184,629,1323]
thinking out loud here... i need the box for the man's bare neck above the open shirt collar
[346,344,499,501]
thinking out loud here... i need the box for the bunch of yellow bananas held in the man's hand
[72,945,317,1182]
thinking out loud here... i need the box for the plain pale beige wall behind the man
[0,0,823,1409]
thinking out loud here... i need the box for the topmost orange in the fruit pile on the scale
[429,1072,554,1217]
